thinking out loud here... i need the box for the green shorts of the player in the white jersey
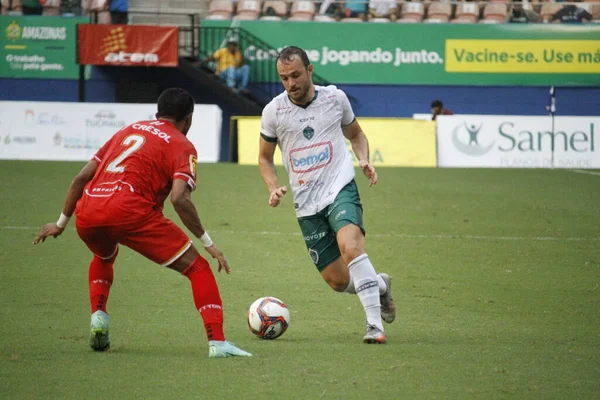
[298,180,365,272]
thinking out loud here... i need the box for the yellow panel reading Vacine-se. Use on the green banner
[446,39,600,74]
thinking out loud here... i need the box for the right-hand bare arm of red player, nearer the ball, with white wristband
[171,179,231,274]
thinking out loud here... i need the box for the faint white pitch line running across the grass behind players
[5,226,600,242]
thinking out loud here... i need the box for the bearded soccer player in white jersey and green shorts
[259,46,396,343]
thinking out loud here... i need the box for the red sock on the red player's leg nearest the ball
[183,257,225,340]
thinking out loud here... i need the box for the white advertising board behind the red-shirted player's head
[0,101,222,163]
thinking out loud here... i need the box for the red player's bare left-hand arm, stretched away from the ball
[33,160,98,244]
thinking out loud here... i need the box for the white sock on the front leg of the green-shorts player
[348,253,383,330]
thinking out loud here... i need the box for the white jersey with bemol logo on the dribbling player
[260,85,354,217]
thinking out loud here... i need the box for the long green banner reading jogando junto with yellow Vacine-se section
[200,21,600,86]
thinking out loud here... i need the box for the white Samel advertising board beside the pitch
[437,115,600,168]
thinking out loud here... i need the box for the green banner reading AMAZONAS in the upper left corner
[0,15,89,79]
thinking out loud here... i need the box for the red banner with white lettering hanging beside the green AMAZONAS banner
[77,24,179,67]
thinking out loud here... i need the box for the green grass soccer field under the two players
[0,162,600,399]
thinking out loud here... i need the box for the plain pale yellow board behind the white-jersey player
[235,117,437,167]
